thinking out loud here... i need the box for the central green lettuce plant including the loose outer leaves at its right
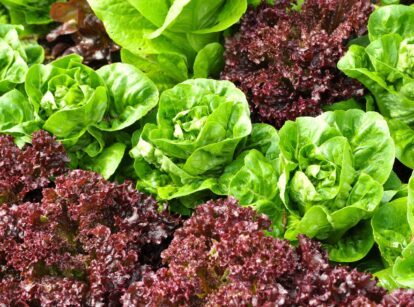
[130,79,285,227]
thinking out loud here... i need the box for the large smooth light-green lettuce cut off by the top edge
[88,0,243,90]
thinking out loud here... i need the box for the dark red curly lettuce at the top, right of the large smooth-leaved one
[221,0,373,127]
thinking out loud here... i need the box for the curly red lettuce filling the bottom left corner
[0,131,180,306]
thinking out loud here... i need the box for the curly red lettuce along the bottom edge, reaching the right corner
[121,198,414,306]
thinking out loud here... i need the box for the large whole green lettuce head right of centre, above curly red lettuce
[278,110,395,262]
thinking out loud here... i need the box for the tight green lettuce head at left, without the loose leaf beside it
[25,55,108,143]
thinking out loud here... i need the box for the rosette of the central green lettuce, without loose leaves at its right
[131,79,252,212]
